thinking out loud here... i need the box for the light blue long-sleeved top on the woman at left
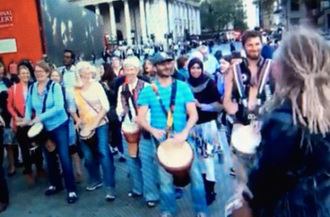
[25,82,68,131]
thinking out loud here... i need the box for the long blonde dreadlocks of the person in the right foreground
[267,26,330,135]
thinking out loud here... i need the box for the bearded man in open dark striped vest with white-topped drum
[223,31,273,179]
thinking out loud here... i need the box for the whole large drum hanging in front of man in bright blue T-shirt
[157,139,194,187]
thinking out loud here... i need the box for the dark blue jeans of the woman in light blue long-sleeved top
[43,121,76,192]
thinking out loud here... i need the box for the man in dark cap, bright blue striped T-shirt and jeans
[138,52,208,217]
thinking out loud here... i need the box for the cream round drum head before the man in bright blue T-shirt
[157,139,194,169]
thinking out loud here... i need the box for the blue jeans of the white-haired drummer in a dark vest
[123,136,159,201]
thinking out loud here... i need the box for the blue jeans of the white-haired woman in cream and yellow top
[80,124,115,189]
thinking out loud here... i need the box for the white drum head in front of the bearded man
[231,125,261,154]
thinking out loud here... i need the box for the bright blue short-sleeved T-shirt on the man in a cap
[138,81,195,133]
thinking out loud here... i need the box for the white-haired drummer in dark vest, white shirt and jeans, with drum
[116,57,159,207]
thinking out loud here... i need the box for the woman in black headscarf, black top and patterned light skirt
[188,58,222,205]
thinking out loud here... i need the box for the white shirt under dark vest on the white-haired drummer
[116,79,150,123]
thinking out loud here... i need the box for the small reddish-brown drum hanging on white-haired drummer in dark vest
[121,122,141,158]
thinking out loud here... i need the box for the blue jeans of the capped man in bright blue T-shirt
[158,137,209,215]
